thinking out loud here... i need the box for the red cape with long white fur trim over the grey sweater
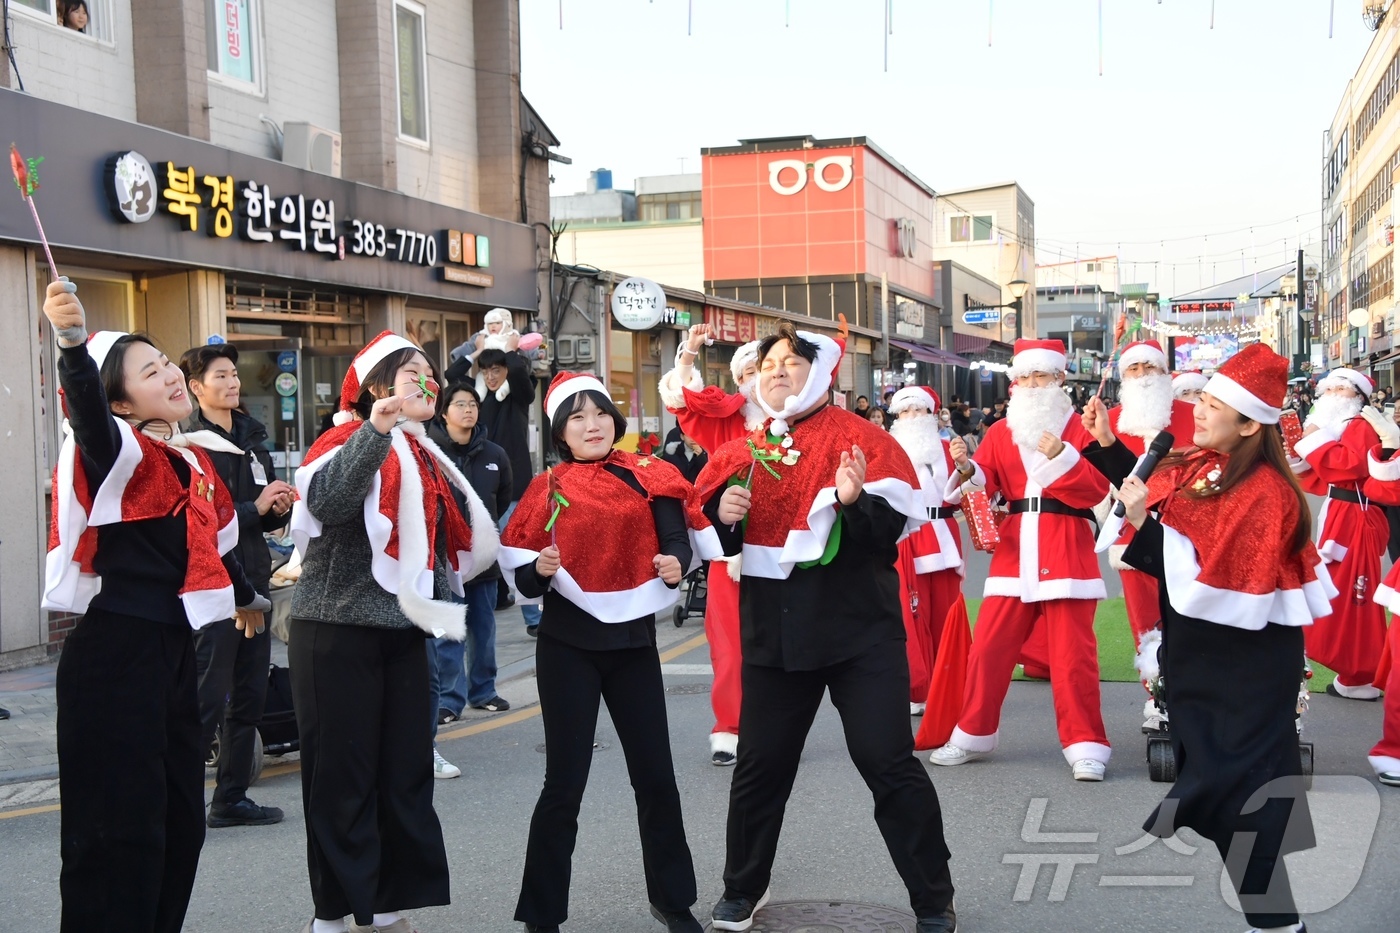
[291,420,498,642]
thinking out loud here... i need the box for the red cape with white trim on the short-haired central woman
[501,450,690,622]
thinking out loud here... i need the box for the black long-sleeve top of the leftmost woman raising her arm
[57,337,255,625]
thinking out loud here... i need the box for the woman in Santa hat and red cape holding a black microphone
[1084,343,1333,932]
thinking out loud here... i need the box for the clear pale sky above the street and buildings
[521,0,1377,294]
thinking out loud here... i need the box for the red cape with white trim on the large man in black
[686,405,928,580]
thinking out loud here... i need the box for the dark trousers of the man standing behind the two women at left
[195,602,272,810]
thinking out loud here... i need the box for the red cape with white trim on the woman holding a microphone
[1148,451,1337,630]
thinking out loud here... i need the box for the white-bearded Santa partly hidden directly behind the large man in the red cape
[889,385,965,716]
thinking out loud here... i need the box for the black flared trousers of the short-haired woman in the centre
[515,629,696,926]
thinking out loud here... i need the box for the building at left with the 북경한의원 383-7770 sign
[0,0,559,665]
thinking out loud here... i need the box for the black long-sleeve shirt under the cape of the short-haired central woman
[515,464,692,651]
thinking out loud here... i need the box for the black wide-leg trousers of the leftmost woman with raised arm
[55,609,204,933]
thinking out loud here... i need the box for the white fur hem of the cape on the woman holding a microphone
[1162,525,1337,632]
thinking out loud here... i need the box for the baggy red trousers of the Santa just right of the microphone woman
[1303,523,1389,686]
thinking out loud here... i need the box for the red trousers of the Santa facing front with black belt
[952,597,1109,761]
